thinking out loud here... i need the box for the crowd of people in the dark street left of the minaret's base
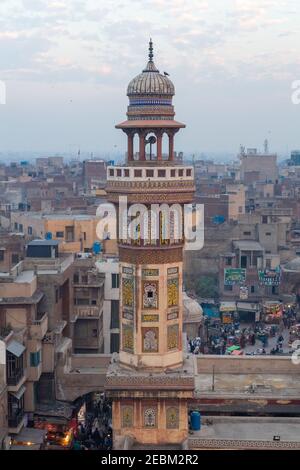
[72,394,112,450]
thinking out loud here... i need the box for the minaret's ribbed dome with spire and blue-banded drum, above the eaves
[127,39,175,120]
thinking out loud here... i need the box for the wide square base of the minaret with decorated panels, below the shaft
[105,356,195,448]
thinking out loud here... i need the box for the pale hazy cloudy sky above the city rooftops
[0,0,300,158]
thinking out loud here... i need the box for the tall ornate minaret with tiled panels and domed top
[106,40,195,445]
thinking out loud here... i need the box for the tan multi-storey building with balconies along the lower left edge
[0,261,48,433]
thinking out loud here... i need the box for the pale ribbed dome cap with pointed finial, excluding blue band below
[127,40,175,97]
